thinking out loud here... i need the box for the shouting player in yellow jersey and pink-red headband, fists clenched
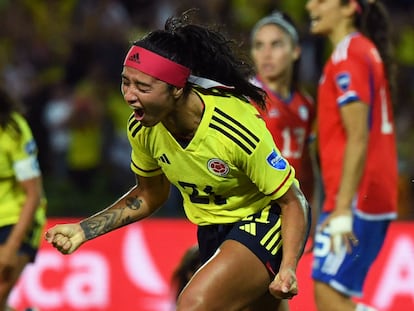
[46,13,309,311]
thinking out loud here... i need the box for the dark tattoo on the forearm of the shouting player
[80,196,142,240]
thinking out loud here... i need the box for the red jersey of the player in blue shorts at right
[317,33,398,219]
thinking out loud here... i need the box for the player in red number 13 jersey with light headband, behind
[251,11,315,202]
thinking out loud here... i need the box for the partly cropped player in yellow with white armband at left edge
[0,88,46,311]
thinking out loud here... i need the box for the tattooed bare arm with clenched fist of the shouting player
[45,175,170,254]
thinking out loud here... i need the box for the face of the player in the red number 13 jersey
[251,24,298,81]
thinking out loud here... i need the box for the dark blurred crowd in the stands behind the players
[0,0,414,220]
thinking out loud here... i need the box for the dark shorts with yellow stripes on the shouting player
[197,204,310,275]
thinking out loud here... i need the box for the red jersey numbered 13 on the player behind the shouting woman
[252,76,315,195]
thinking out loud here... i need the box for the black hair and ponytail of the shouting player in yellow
[134,10,265,107]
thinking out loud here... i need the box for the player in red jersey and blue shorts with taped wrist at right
[307,0,397,311]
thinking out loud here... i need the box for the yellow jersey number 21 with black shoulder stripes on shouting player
[128,89,297,225]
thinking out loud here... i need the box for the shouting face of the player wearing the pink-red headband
[121,66,175,127]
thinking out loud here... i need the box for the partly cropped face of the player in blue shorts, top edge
[306,0,344,36]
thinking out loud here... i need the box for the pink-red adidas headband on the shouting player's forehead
[124,45,190,87]
